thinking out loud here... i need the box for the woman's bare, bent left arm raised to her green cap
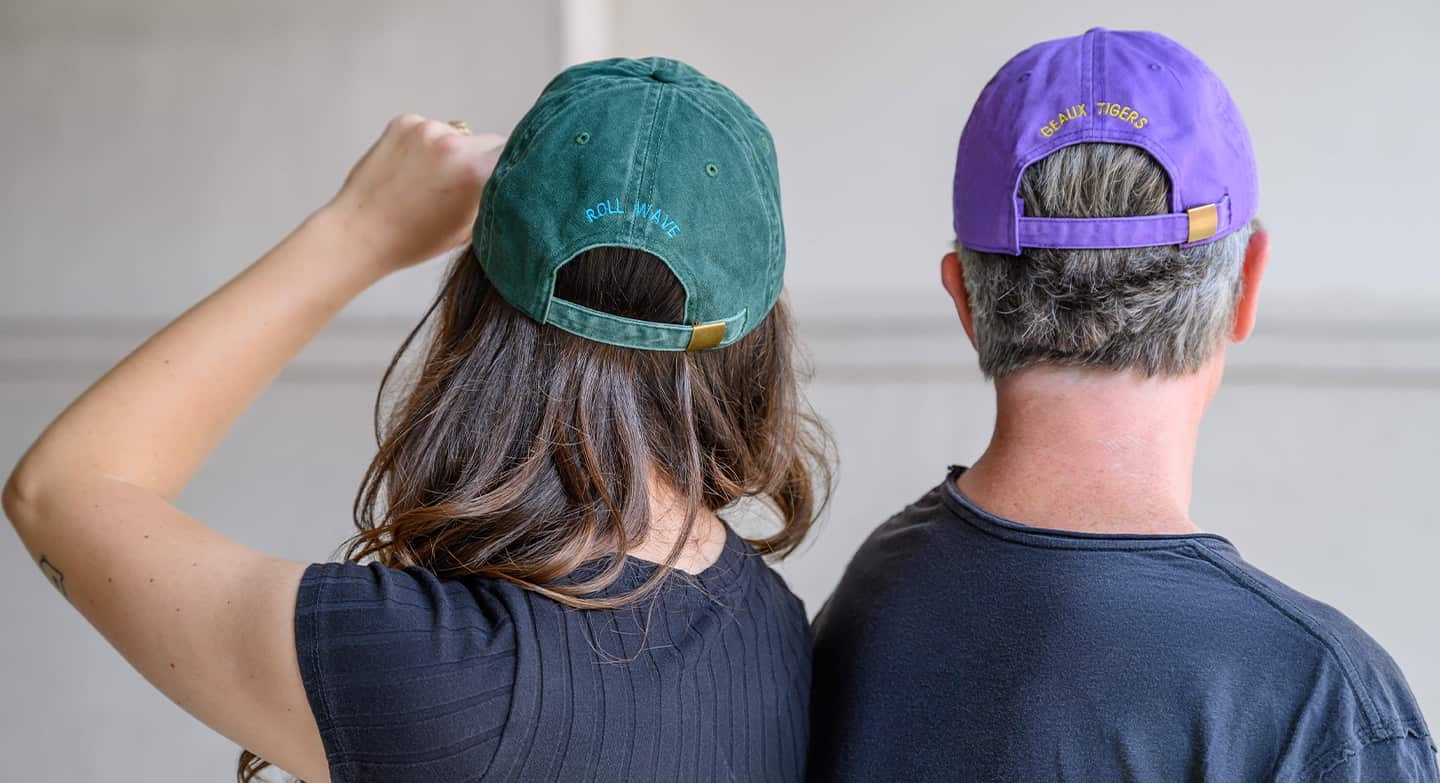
[4,115,500,782]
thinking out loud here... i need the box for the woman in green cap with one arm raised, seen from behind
[4,59,828,782]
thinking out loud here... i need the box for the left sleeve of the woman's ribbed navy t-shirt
[295,563,516,783]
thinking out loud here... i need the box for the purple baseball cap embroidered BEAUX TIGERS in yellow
[955,27,1260,255]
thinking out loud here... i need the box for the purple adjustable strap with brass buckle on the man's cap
[1017,196,1230,249]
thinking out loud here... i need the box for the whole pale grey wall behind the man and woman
[0,0,1440,782]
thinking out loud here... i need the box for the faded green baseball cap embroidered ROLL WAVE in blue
[474,58,785,351]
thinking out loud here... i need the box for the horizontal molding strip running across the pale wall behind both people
[0,294,1440,390]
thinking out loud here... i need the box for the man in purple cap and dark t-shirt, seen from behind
[809,29,1440,783]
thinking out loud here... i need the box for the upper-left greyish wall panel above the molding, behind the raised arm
[0,0,562,320]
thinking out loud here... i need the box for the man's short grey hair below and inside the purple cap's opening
[959,142,1254,377]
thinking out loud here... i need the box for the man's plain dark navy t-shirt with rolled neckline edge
[809,469,1440,783]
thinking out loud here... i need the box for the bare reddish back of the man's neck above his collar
[958,361,1221,534]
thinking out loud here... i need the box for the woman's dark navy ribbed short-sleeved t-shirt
[295,528,811,783]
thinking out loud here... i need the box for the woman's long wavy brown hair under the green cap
[238,248,832,783]
